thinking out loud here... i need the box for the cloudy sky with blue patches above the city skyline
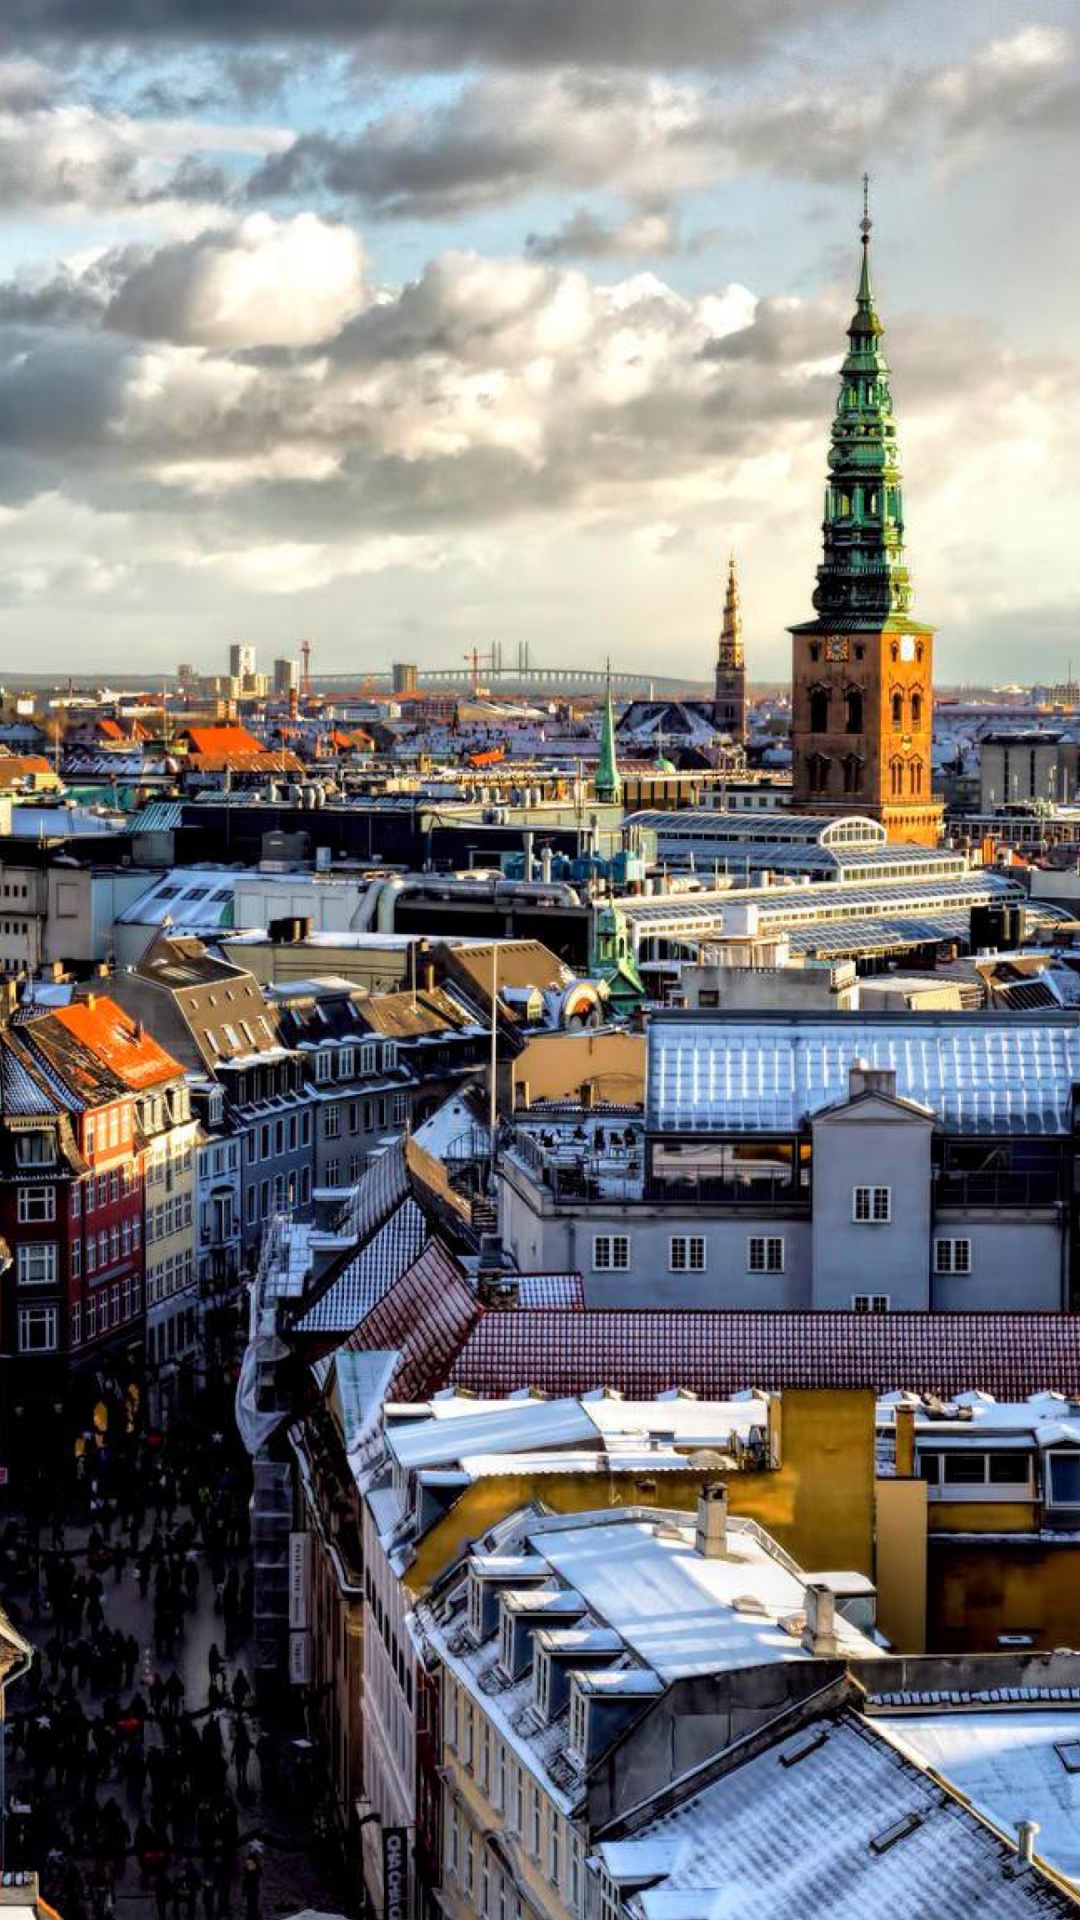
[0,0,1080,685]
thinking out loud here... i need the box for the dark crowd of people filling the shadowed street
[0,1405,297,1920]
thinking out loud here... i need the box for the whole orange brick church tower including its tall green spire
[790,196,942,847]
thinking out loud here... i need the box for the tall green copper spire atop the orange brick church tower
[813,177,911,630]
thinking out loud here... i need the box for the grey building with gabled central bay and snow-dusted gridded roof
[500,1010,1080,1313]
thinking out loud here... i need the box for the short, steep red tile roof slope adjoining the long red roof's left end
[344,1236,480,1400]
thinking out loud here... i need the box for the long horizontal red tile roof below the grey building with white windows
[448,1308,1080,1400]
